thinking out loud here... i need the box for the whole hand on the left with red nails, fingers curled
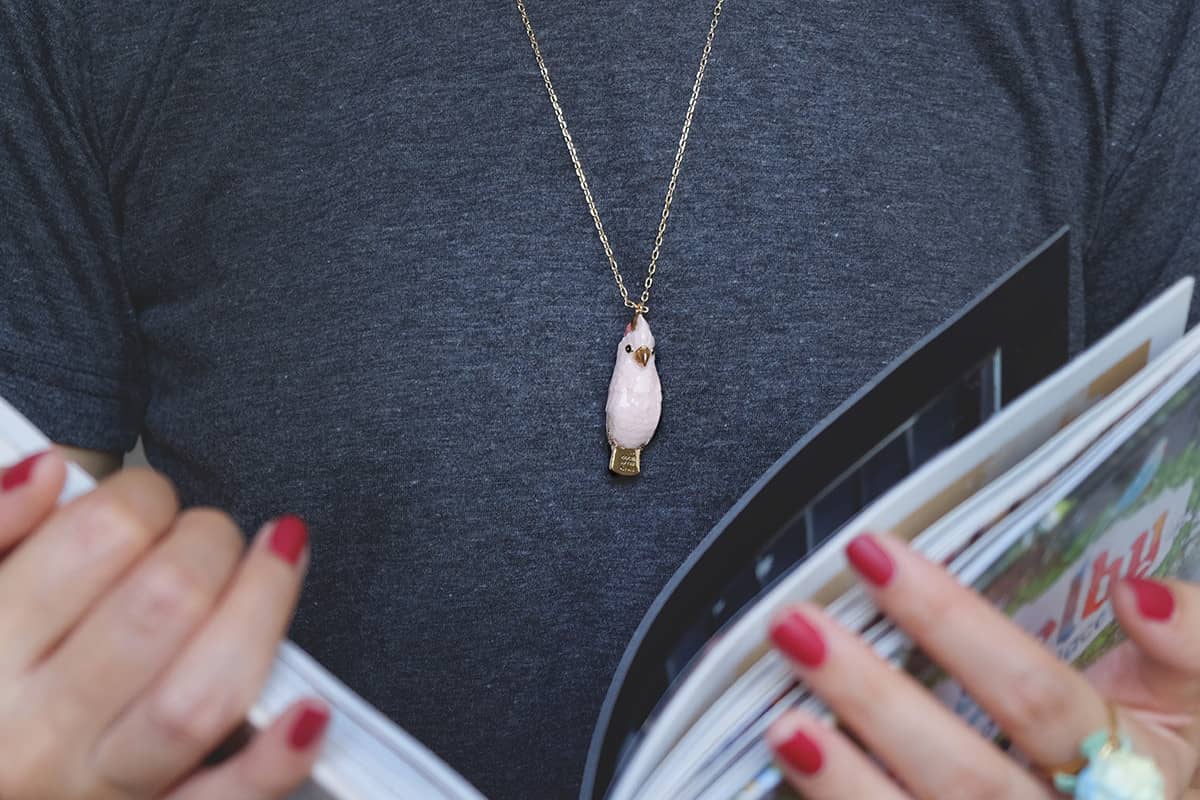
[0,452,329,800]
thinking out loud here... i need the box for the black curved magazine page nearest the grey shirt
[580,227,1072,799]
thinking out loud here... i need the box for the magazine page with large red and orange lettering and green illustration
[925,350,1200,734]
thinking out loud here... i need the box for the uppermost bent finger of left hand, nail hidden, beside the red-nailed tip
[0,469,179,674]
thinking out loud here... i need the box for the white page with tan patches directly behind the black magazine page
[610,278,1193,800]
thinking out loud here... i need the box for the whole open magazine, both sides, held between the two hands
[0,231,1200,800]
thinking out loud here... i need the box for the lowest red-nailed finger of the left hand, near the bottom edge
[166,700,329,800]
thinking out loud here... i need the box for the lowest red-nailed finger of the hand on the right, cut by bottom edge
[767,711,908,800]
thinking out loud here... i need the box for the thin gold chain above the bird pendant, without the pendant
[516,0,725,314]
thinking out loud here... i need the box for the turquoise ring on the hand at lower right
[1049,704,1165,800]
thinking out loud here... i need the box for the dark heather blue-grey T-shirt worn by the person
[0,0,1200,798]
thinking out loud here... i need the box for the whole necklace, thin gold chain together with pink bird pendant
[516,0,725,475]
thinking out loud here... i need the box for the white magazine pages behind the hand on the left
[0,397,482,800]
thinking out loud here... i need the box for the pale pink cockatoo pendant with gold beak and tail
[605,314,662,475]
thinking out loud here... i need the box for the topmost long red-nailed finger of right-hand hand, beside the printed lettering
[847,534,1108,764]
